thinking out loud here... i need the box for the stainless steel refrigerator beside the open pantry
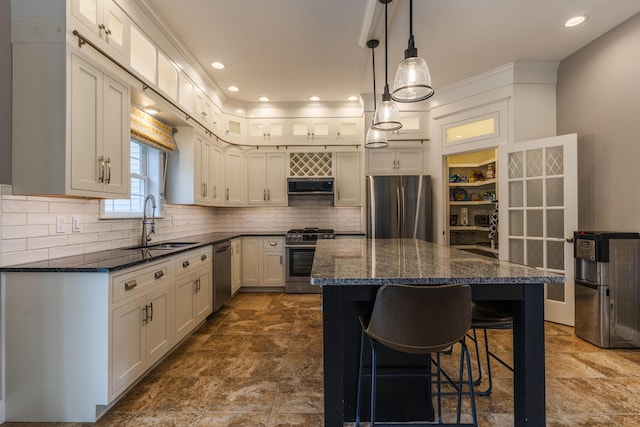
[367,175,433,242]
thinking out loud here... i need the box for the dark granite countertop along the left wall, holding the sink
[0,231,286,272]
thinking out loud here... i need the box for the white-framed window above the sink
[100,140,166,219]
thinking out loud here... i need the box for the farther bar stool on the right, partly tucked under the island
[471,301,513,396]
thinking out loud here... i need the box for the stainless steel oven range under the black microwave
[284,227,335,294]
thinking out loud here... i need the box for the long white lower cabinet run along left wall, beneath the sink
[1,246,213,423]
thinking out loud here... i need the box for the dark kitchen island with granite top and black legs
[311,239,564,427]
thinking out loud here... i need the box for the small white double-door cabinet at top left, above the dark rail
[71,0,131,62]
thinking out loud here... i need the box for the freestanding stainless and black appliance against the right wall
[573,231,640,348]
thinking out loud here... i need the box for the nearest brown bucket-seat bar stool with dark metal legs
[356,284,477,427]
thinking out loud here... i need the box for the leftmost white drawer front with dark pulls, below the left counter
[112,262,171,303]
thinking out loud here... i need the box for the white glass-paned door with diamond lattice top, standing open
[499,134,578,325]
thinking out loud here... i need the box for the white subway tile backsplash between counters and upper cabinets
[0,185,362,266]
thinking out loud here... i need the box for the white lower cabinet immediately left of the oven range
[242,237,284,287]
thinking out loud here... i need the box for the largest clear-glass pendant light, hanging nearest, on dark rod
[391,0,434,102]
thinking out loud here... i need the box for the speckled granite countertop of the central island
[311,239,564,286]
